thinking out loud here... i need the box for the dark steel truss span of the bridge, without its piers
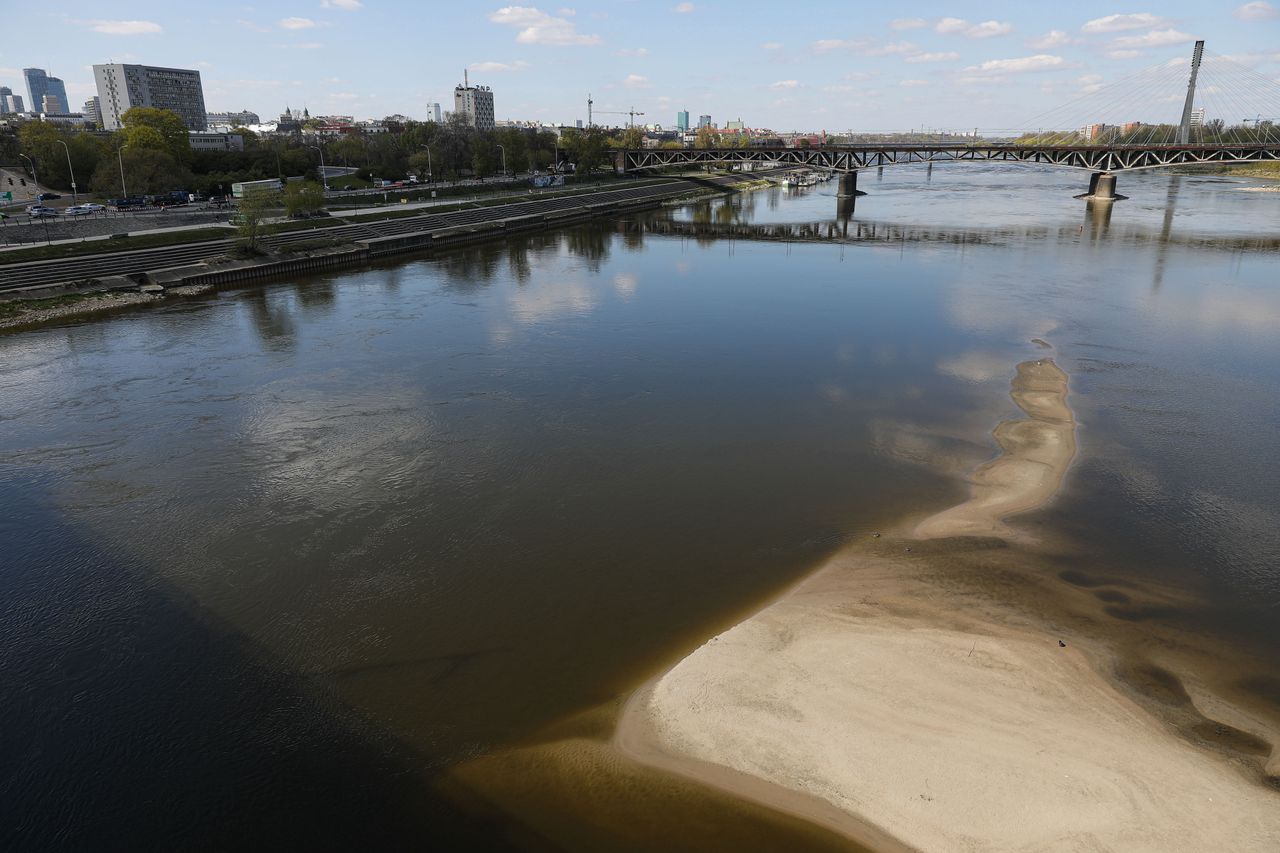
[611,142,1280,173]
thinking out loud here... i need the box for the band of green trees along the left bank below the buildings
[0,108,643,196]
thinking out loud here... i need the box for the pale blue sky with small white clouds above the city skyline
[0,0,1280,132]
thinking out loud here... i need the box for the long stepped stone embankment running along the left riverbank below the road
[0,178,711,292]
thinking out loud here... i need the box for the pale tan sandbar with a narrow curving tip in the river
[614,350,1280,852]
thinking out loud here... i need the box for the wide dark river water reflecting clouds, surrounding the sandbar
[0,164,1280,849]
